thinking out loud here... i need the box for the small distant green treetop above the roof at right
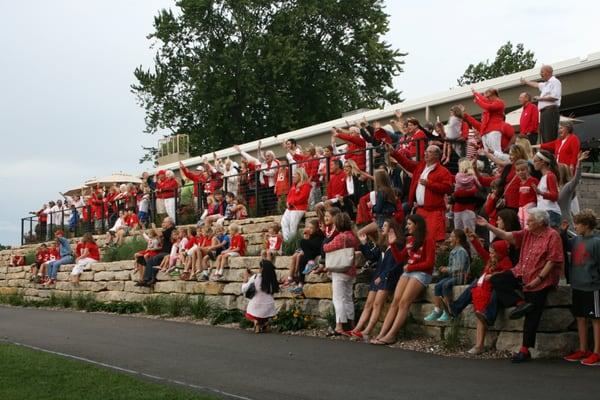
[458,42,536,86]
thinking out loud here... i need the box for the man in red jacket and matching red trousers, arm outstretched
[391,145,454,241]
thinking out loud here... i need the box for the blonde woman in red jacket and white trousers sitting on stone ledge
[281,168,312,241]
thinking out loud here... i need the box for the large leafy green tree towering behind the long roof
[131,0,405,160]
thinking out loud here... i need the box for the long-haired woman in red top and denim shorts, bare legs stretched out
[371,214,435,345]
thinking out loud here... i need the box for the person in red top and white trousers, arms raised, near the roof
[471,88,504,153]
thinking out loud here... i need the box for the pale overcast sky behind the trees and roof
[0,0,600,245]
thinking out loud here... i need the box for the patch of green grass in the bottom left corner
[0,343,215,400]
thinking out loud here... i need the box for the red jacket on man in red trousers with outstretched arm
[392,151,454,211]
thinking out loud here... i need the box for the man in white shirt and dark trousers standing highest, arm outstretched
[521,65,562,143]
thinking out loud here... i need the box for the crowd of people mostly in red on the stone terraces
[22,66,600,365]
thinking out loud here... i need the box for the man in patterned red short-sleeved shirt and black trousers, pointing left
[477,208,564,363]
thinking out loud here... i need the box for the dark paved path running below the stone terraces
[0,306,600,400]
